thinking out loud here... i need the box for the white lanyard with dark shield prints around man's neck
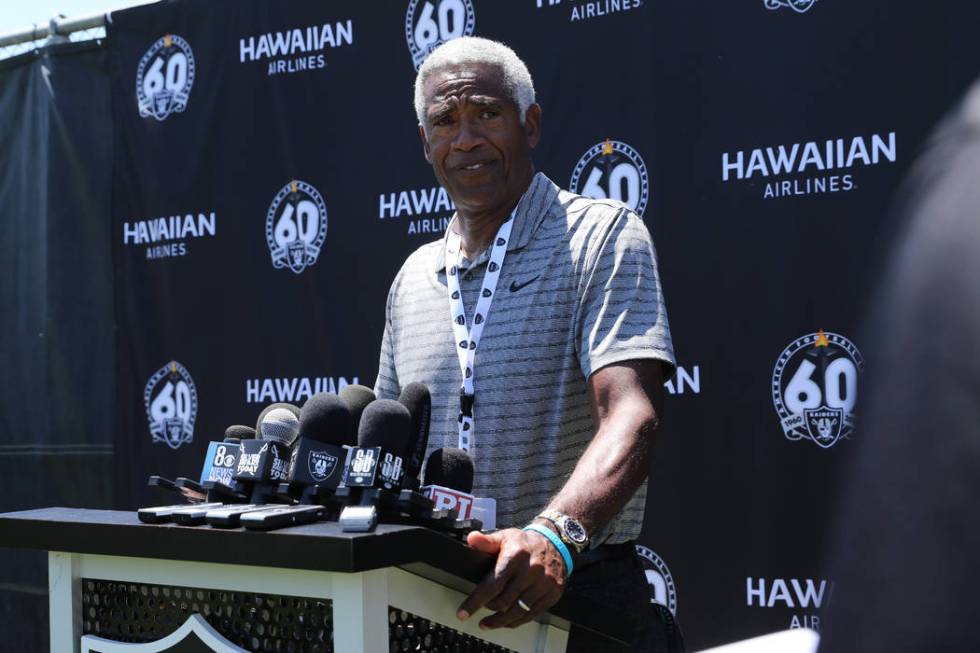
[446,209,516,452]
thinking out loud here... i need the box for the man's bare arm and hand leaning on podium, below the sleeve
[458,359,663,628]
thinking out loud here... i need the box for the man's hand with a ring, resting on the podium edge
[456,528,566,628]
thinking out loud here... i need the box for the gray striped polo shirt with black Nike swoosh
[375,173,674,544]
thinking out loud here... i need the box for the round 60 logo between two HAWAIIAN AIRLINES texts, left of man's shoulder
[265,181,327,274]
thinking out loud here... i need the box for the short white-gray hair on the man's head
[415,36,534,127]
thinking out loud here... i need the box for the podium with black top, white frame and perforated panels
[0,508,632,653]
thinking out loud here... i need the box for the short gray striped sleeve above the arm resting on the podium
[577,209,675,380]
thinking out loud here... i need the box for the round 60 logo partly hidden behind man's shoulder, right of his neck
[568,138,650,216]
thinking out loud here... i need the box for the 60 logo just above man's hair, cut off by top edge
[405,0,476,70]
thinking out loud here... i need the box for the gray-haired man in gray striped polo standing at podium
[376,38,674,650]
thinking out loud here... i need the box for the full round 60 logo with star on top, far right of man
[772,329,864,449]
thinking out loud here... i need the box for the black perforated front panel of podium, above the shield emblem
[82,579,334,653]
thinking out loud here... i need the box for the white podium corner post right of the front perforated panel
[333,569,388,653]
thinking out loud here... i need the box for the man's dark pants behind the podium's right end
[565,544,684,653]
